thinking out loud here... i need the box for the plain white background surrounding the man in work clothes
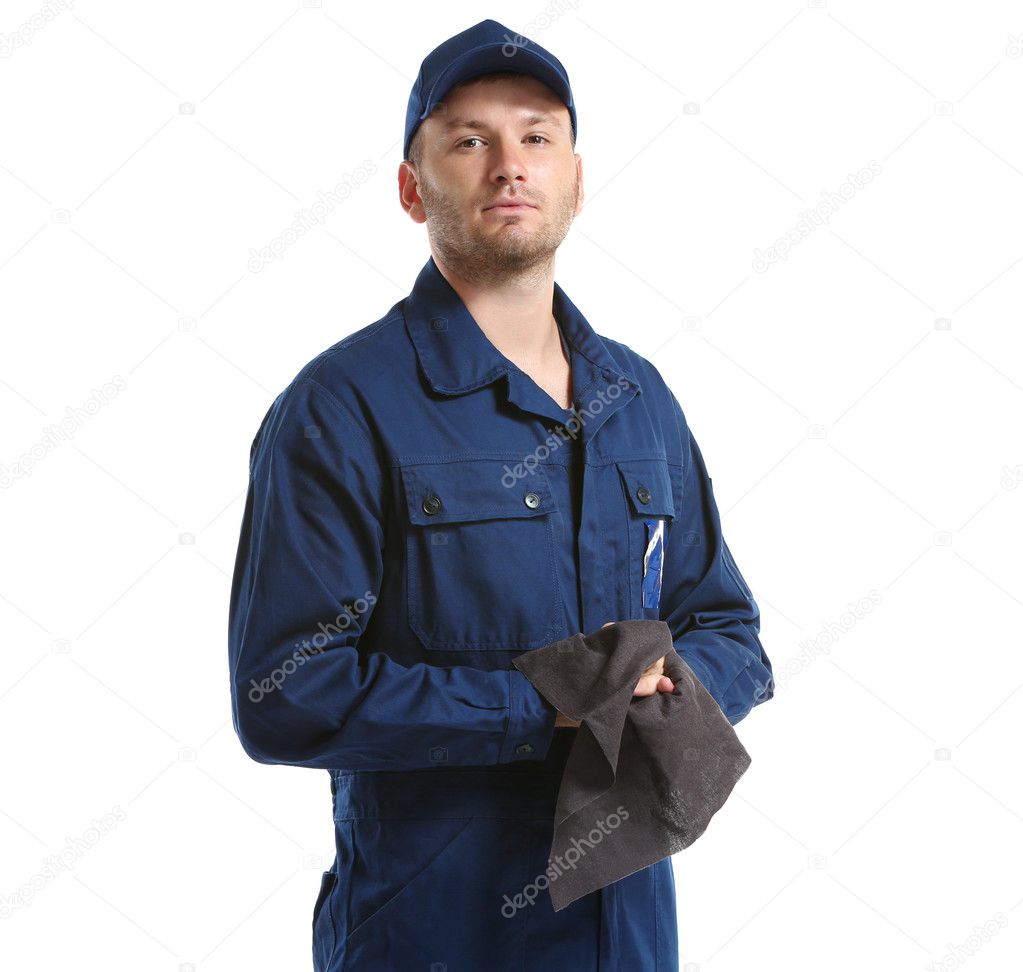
[0,0,1023,972]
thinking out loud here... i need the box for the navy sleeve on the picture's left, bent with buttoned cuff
[228,375,555,770]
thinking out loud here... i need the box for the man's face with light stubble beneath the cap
[399,75,583,278]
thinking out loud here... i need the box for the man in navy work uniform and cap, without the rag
[230,20,773,972]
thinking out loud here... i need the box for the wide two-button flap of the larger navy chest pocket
[401,456,557,525]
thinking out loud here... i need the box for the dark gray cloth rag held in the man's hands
[513,619,751,912]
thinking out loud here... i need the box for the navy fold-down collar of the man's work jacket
[402,256,641,395]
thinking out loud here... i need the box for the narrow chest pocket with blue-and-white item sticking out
[615,457,680,618]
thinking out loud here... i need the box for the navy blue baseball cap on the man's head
[403,20,577,159]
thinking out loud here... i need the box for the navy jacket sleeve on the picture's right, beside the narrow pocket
[661,395,774,725]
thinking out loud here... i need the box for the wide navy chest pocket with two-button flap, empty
[401,456,561,652]
